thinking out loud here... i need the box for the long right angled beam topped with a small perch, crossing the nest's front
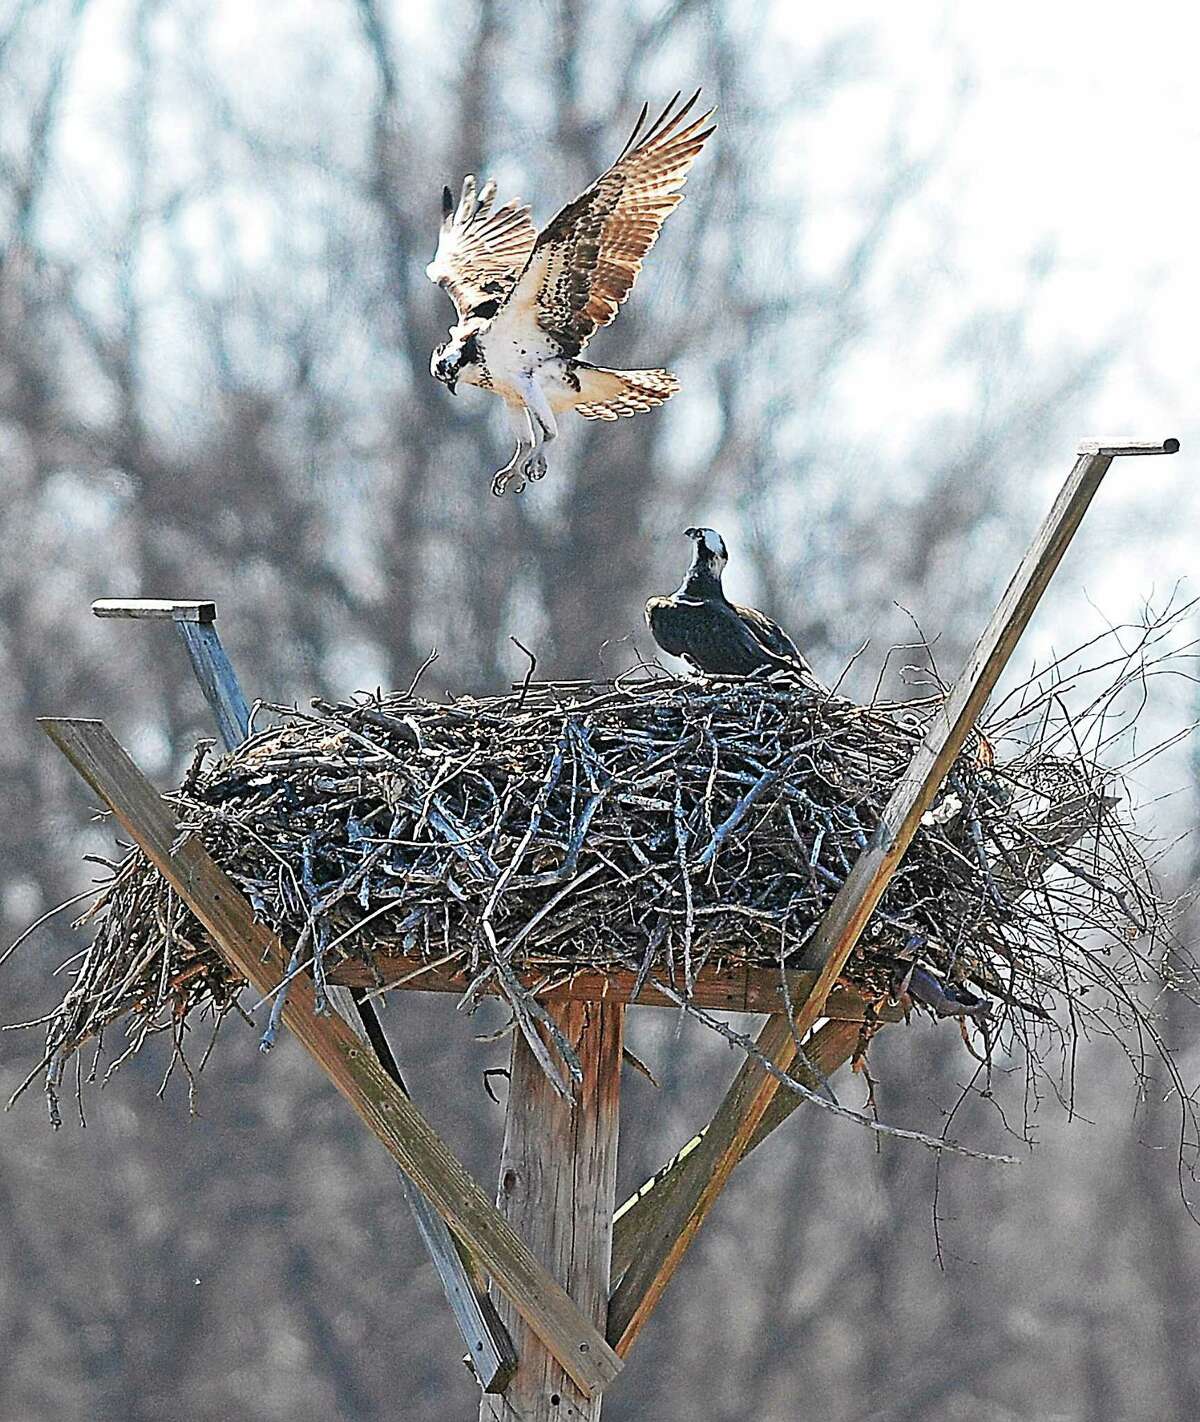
[609,439,1179,1357]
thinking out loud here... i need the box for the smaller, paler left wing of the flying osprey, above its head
[425,176,537,320]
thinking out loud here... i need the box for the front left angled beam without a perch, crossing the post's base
[40,718,621,1396]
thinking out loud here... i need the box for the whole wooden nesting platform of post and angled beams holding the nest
[41,441,1179,1422]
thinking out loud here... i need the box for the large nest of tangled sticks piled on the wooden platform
[14,651,1159,1114]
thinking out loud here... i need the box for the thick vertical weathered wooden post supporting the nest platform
[479,1001,624,1422]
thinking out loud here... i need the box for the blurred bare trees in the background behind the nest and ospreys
[0,0,1200,1422]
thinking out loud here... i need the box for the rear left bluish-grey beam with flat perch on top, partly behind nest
[91,597,516,1392]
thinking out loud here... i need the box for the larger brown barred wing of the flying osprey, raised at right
[512,90,715,356]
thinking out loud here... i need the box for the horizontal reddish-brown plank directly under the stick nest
[328,953,863,1022]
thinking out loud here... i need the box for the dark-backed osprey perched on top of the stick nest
[645,529,820,685]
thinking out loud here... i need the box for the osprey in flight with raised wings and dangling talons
[425,90,712,495]
